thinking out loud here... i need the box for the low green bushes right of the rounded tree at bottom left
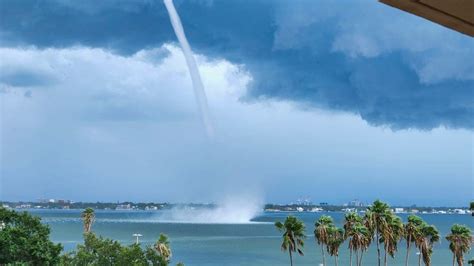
[61,233,171,266]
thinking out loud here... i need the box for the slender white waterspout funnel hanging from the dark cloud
[163,0,214,137]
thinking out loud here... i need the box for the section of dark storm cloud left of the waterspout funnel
[0,1,172,53]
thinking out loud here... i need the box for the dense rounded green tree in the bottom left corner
[0,208,62,265]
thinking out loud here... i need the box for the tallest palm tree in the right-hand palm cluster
[366,200,391,266]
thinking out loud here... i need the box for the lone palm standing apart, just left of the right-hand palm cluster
[275,216,306,265]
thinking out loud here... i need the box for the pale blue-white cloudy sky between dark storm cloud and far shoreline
[0,44,472,205]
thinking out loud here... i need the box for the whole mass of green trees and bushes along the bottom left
[0,208,183,266]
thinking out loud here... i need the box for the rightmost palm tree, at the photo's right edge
[446,224,472,266]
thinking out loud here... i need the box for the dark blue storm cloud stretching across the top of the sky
[0,0,474,129]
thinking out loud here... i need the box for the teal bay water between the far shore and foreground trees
[31,210,473,266]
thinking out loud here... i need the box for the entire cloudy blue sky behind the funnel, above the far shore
[0,0,474,205]
